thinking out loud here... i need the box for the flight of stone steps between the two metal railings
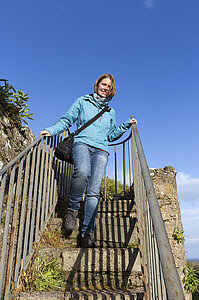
[29,200,143,294]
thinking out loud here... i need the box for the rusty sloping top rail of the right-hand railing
[132,125,185,300]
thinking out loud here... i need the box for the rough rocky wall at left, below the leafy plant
[0,104,35,169]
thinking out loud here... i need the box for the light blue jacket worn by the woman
[45,94,131,152]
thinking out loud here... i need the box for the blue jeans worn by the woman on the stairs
[68,142,108,237]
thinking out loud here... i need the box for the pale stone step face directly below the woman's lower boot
[39,247,141,272]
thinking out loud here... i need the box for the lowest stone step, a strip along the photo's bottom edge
[15,289,144,300]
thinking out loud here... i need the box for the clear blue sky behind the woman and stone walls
[0,0,199,258]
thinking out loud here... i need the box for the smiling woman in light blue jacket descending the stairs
[40,73,137,248]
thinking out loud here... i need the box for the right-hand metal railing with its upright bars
[132,125,185,300]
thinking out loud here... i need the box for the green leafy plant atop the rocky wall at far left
[0,79,33,127]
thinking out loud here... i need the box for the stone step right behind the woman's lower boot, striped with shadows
[44,217,138,248]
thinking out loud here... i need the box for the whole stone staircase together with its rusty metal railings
[0,125,185,300]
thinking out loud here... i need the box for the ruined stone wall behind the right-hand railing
[150,167,192,300]
